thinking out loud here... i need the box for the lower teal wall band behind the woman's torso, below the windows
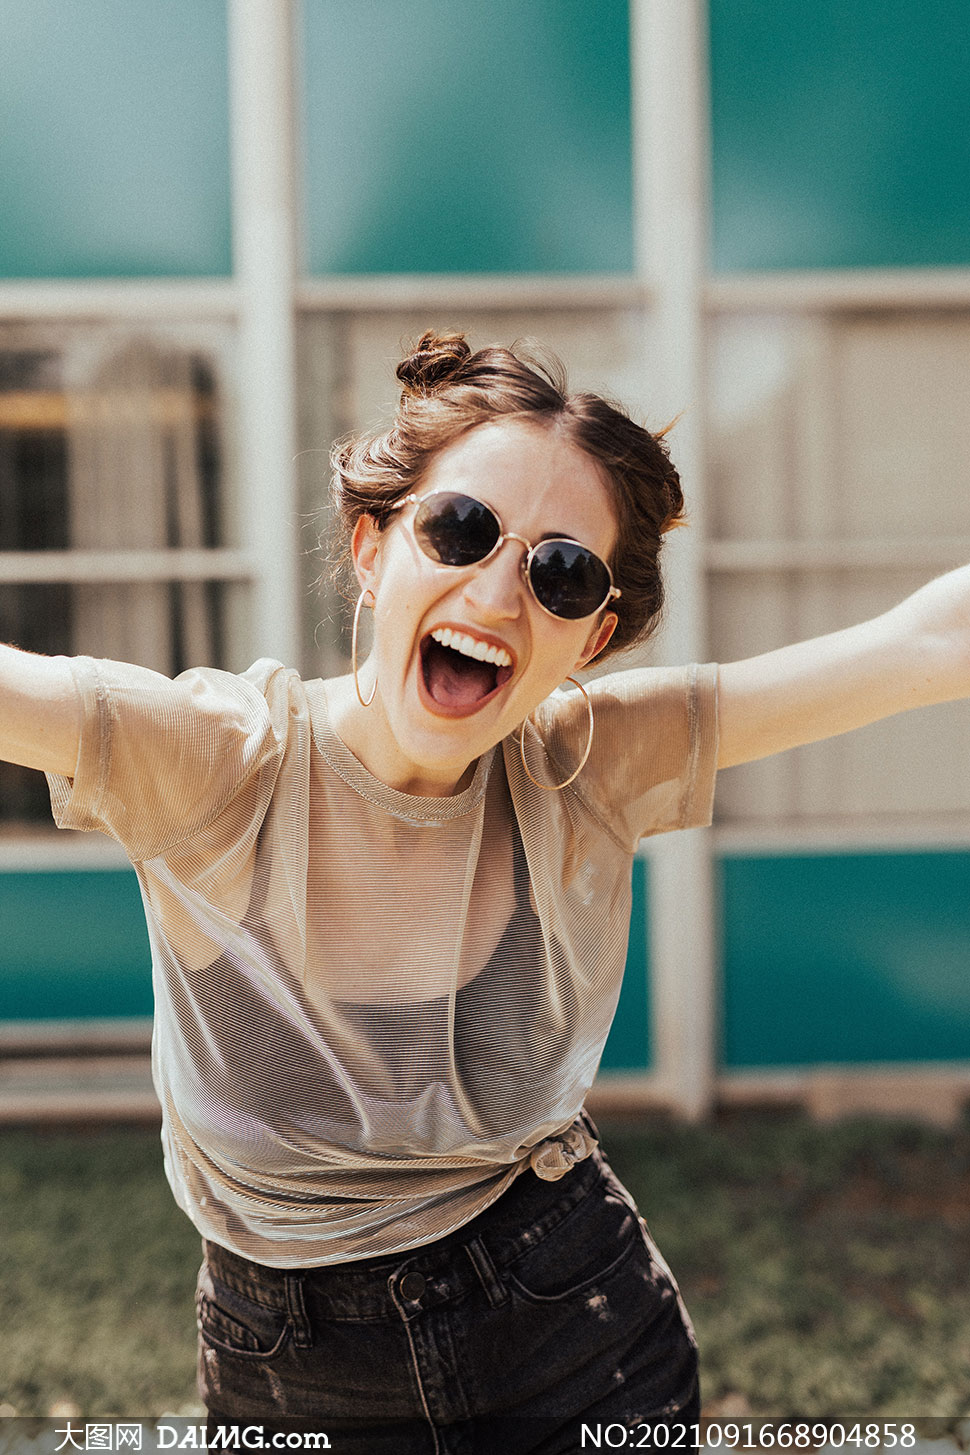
[9,851,970,1071]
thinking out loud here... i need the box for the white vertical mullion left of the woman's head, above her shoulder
[228,0,300,663]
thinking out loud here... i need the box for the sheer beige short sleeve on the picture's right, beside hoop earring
[534,663,717,848]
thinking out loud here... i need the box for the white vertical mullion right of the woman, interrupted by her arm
[631,0,717,1117]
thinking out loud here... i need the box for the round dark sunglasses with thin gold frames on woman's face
[394,490,620,621]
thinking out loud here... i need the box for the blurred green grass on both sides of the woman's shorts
[0,1113,970,1419]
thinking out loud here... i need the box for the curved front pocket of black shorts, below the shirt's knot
[505,1183,643,1304]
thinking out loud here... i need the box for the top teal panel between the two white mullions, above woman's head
[302,0,633,274]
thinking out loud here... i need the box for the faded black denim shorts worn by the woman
[198,1129,700,1455]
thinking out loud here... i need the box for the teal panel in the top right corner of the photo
[710,0,970,271]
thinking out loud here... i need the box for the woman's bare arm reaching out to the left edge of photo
[0,645,80,778]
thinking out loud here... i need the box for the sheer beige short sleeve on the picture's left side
[48,656,286,863]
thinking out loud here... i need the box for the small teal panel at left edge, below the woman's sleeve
[0,869,153,1020]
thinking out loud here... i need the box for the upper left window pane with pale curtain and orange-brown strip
[0,330,224,550]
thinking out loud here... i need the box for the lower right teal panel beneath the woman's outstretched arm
[721,853,970,1067]
